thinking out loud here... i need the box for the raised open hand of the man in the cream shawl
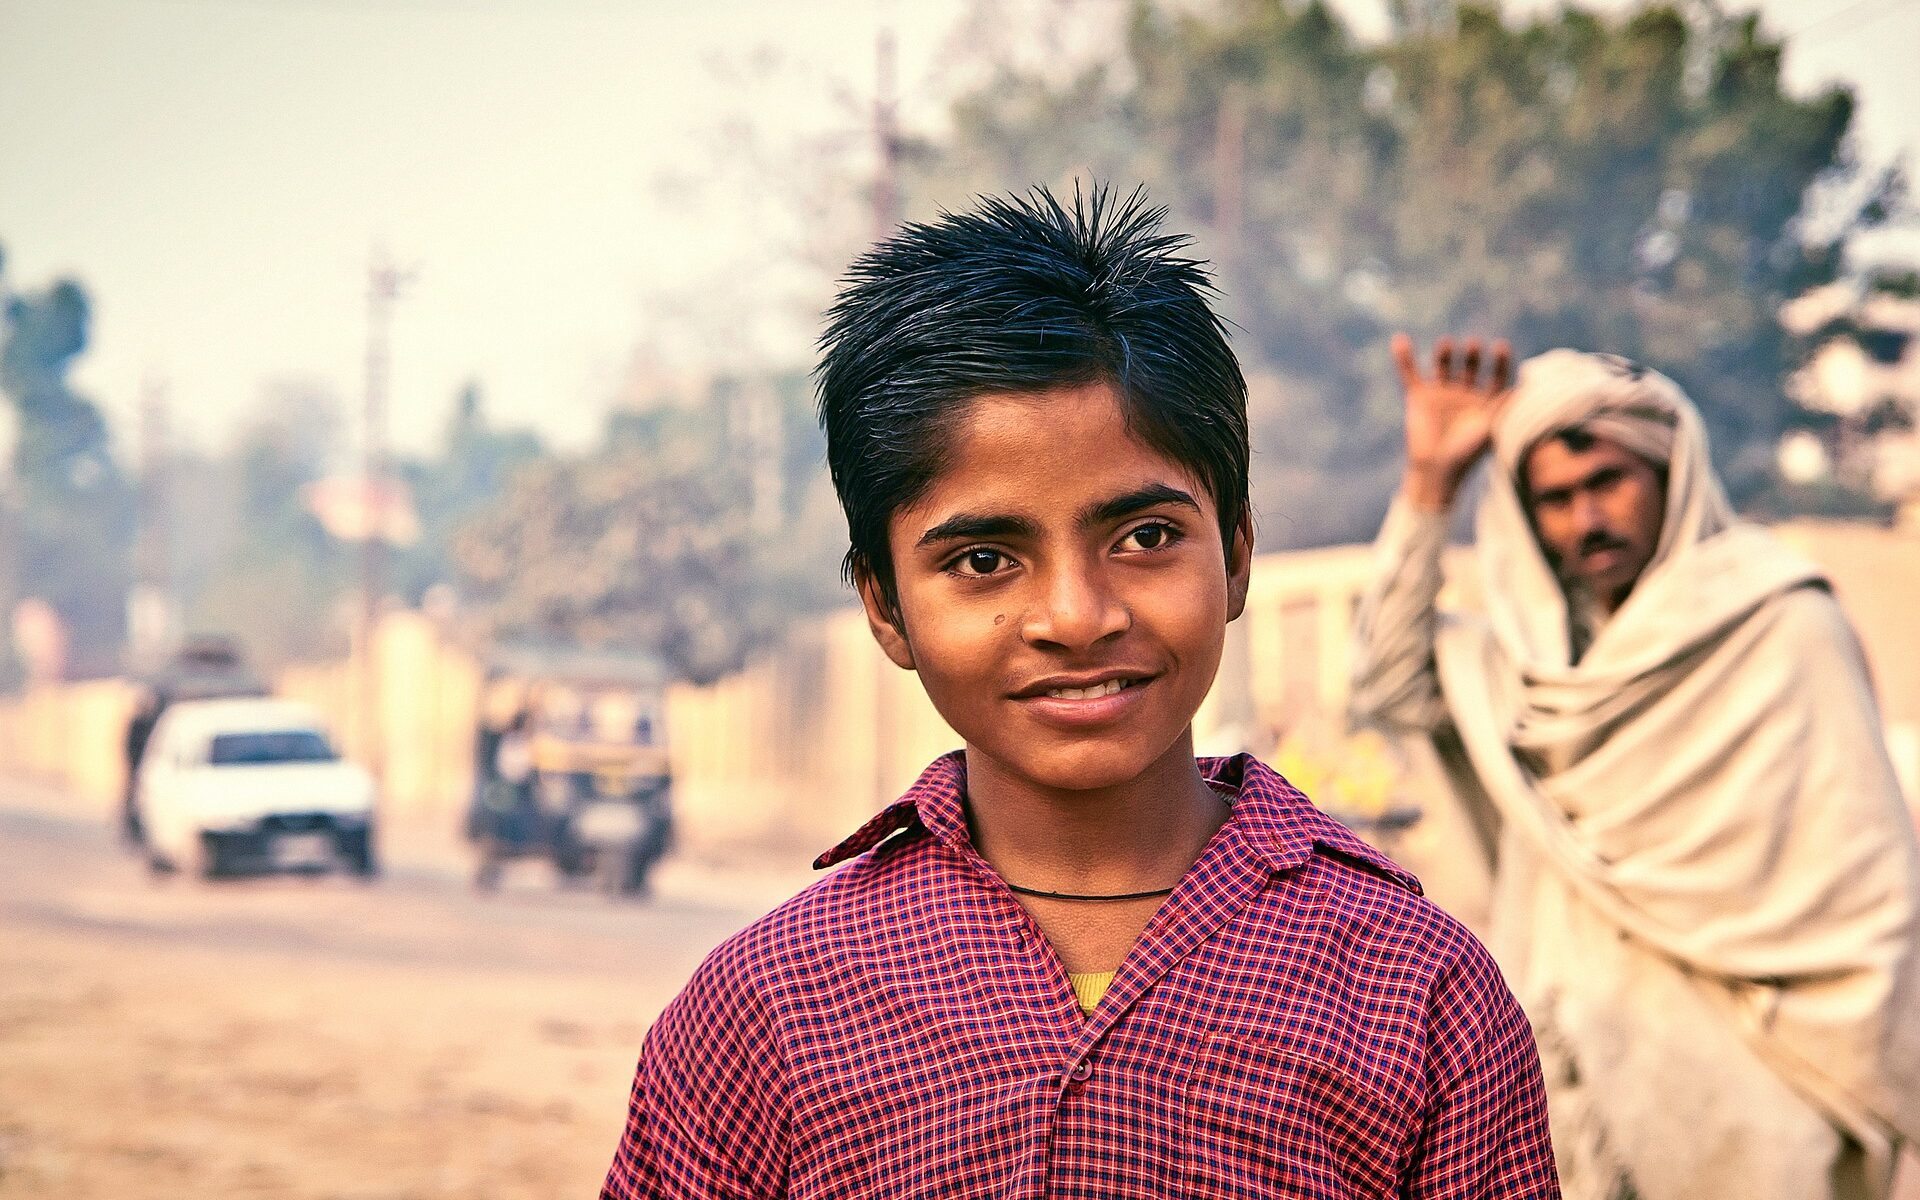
[1394,334,1513,513]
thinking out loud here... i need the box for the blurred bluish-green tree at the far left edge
[0,247,134,676]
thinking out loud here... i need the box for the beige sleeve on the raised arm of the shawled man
[1348,497,1448,733]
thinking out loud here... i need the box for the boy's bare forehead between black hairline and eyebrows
[895,382,1212,532]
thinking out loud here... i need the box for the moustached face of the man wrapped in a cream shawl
[1524,438,1667,612]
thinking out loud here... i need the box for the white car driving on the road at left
[136,699,378,877]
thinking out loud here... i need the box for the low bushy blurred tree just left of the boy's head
[453,376,845,682]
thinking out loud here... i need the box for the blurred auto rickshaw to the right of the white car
[467,647,674,895]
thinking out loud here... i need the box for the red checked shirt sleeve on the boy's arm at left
[601,943,791,1200]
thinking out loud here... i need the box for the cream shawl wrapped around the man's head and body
[1436,351,1920,1200]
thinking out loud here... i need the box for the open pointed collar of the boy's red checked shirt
[814,751,1421,893]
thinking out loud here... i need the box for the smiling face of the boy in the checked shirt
[860,382,1252,789]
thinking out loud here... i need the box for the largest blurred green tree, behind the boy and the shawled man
[912,0,1901,547]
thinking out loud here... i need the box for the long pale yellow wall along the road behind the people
[0,522,1920,858]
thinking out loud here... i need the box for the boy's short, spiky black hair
[814,184,1248,611]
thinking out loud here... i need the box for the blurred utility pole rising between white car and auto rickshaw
[359,250,413,783]
